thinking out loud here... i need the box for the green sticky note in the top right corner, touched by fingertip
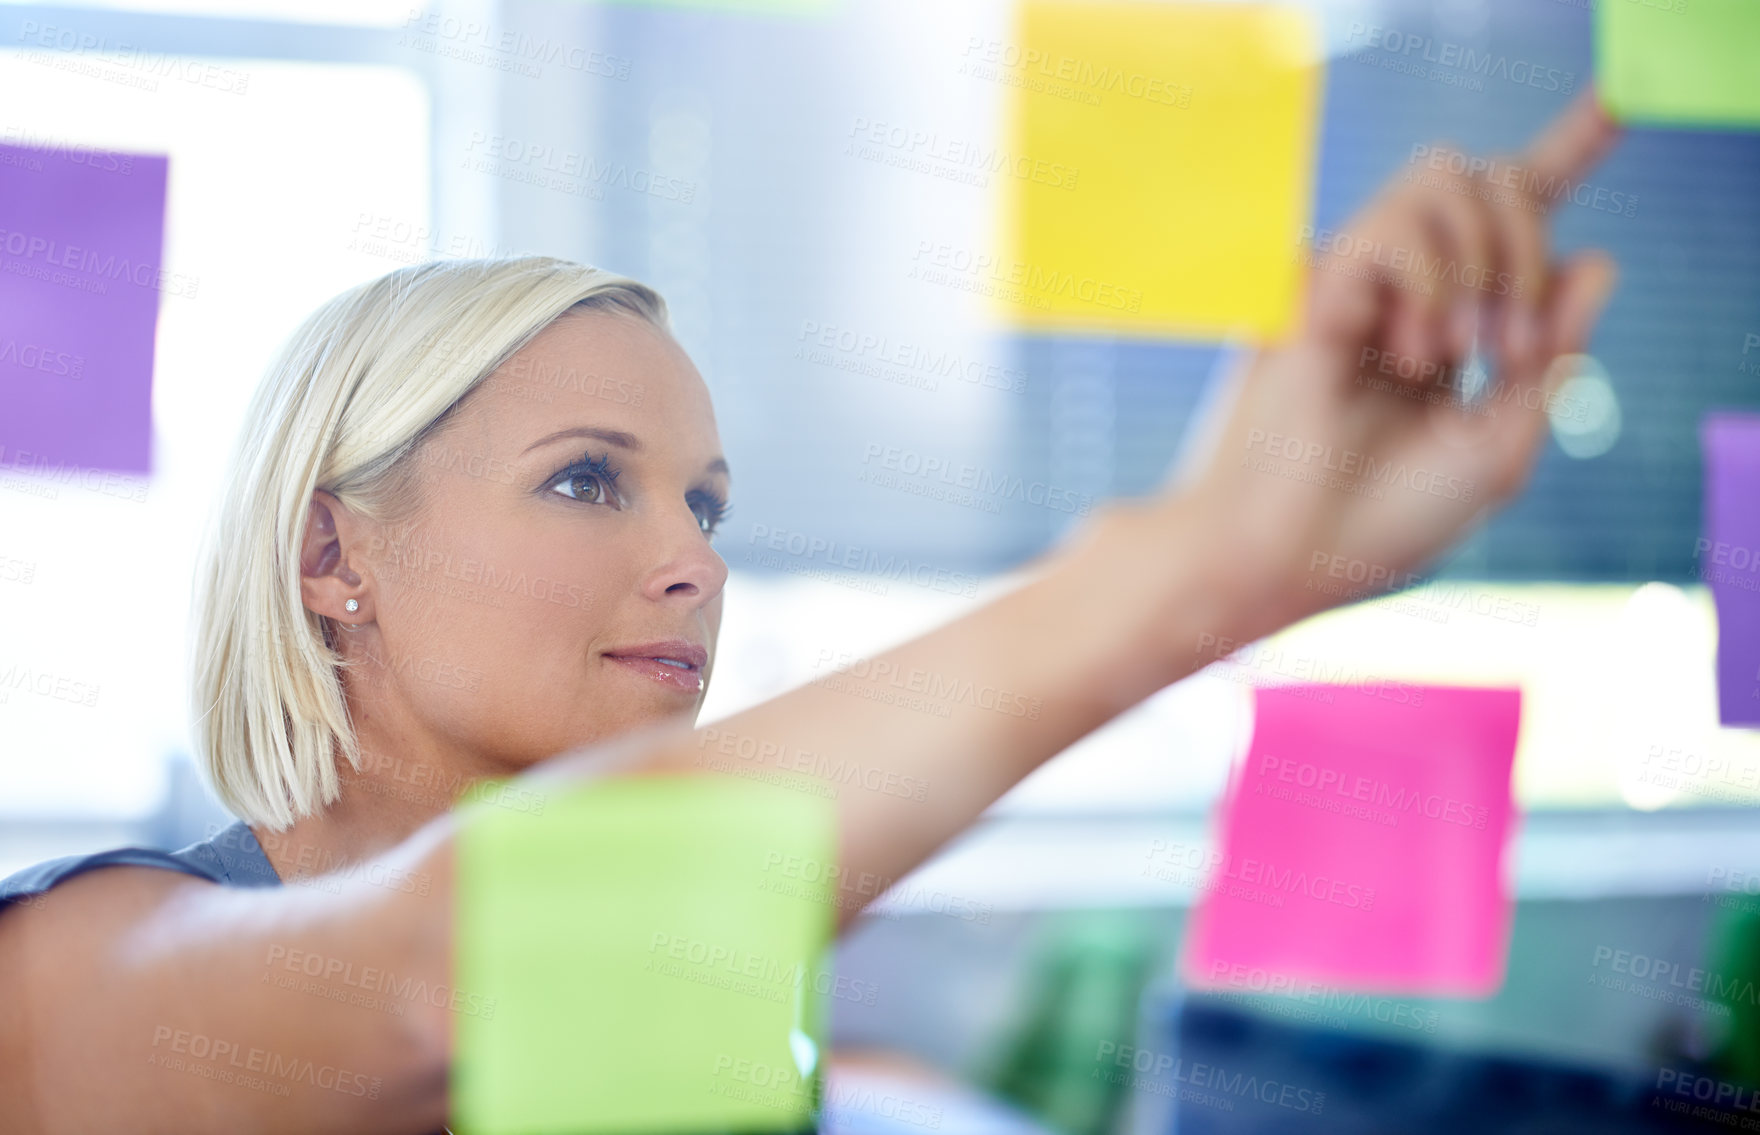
[1595,0,1760,127]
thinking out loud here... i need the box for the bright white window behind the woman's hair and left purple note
[0,51,429,816]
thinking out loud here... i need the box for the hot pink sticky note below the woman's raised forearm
[1183,683,1521,996]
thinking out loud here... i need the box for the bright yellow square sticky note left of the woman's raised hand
[1006,0,1324,340]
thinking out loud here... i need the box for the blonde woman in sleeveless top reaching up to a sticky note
[0,97,1614,1135]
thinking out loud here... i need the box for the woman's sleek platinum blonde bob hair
[194,257,667,831]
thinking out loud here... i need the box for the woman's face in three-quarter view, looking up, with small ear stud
[350,311,729,767]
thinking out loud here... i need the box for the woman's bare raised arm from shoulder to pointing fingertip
[0,95,1614,1135]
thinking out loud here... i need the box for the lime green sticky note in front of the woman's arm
[451,776,836,1135]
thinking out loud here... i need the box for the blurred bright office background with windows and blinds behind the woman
[0,0,1760,1133]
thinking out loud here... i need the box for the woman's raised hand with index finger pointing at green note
[1167,92,1617,641]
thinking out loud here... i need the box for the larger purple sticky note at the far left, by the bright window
[0,144,167,473]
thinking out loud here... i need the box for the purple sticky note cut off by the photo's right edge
[1693,414,1760,725]
